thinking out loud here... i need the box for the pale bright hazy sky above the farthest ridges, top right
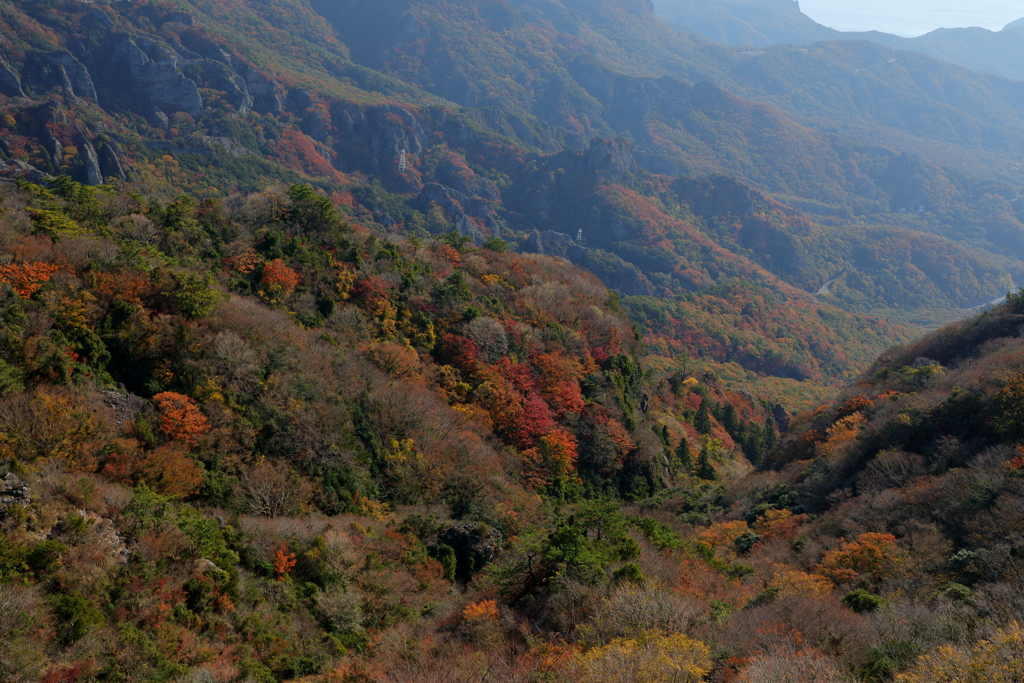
[800,0,1024,36]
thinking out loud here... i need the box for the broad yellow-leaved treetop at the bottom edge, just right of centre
[580,635,712,683]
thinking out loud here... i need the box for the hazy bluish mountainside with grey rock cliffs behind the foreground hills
[3,0,1024,331]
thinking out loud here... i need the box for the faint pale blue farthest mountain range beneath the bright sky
[654,0,1024,80]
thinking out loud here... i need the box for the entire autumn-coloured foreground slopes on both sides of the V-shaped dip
[6,178,1024,683]
